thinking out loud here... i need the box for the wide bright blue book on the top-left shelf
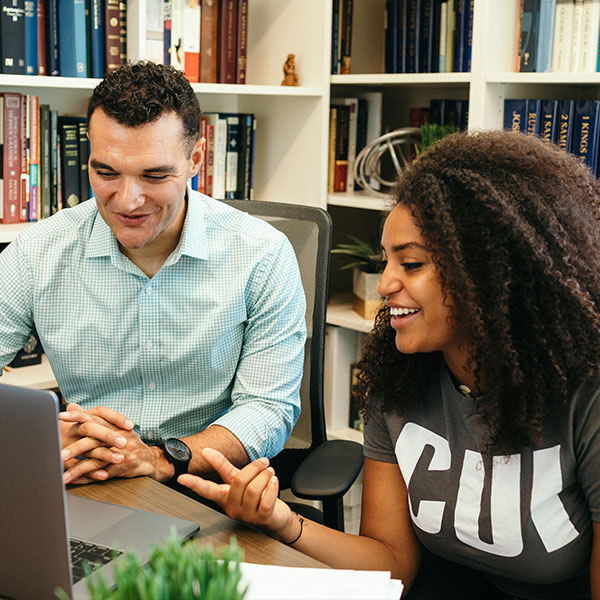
[58,0,88,77]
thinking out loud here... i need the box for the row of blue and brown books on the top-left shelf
[0,0,127,78]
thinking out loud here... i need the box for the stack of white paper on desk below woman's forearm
[241,563,402,600]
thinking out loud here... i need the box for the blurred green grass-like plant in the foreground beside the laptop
[56,535,247,600]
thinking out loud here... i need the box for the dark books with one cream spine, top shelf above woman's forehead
[385,0,474,73]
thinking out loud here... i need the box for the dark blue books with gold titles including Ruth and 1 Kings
[504,99,600,175]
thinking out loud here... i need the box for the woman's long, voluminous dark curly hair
[357,131,600,450]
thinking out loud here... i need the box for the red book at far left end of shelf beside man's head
[2,92,22,224]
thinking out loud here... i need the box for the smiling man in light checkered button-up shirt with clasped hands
[0,63,306,483]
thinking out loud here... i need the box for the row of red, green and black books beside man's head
[0,92,91,224]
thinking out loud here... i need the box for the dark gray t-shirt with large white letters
[364,362,600,600]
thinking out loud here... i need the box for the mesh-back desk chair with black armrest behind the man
[225,200,363,531]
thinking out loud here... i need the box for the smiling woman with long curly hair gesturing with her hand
[179,132,600,600]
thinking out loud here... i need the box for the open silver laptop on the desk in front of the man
[0,384,198,598]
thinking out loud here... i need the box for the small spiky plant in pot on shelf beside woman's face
[331,234,383,319]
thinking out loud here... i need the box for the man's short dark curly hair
[87,61,200,152]
